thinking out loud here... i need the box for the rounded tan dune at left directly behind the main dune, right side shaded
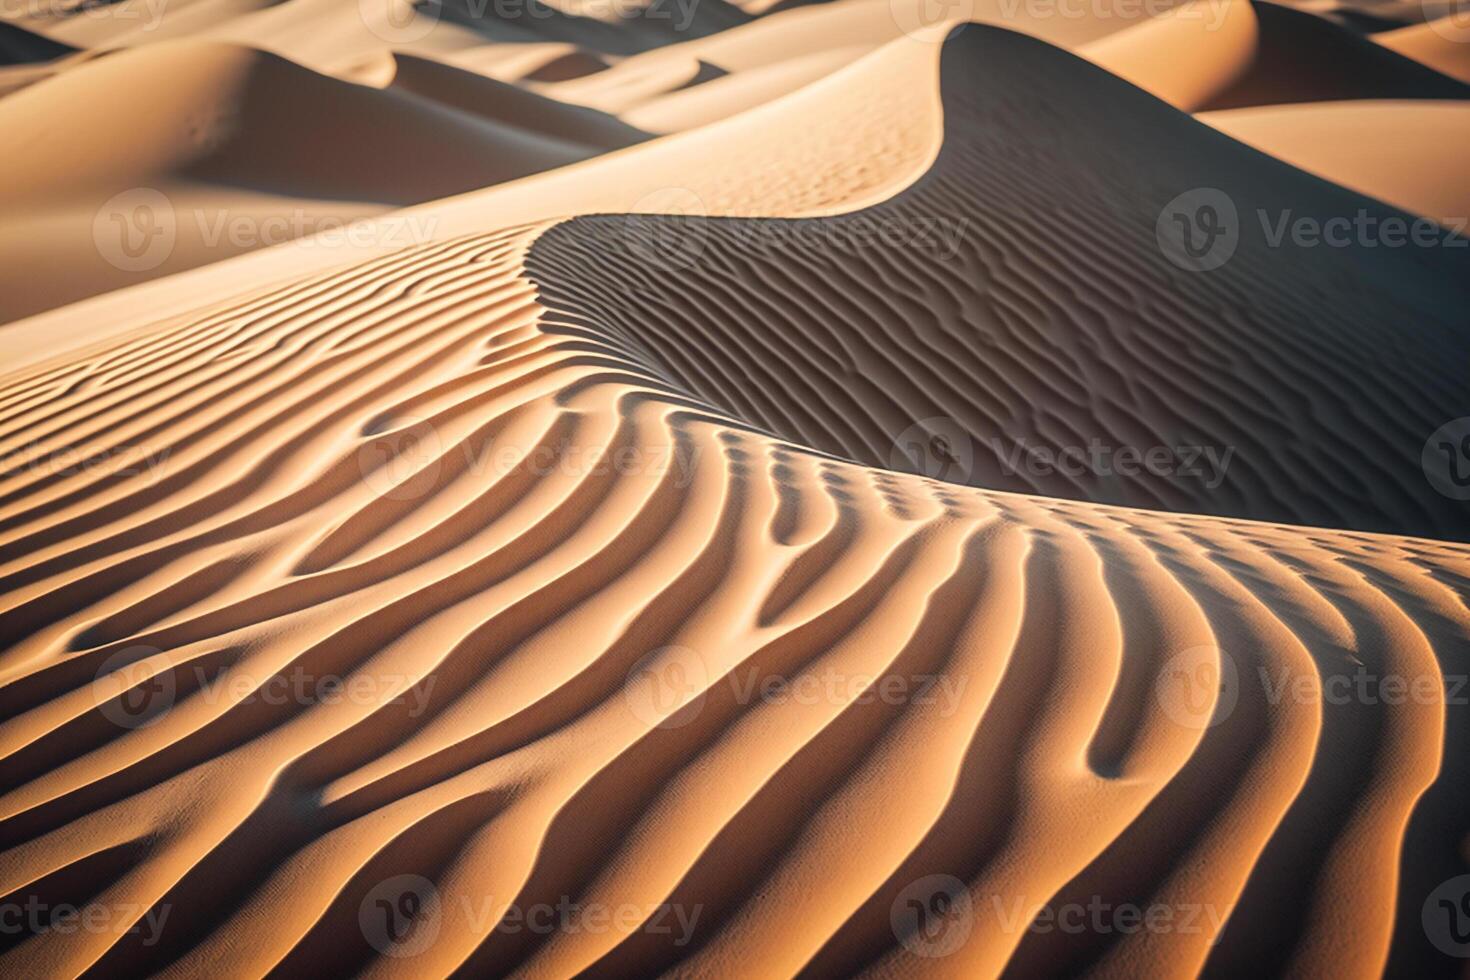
[0,41,614,319]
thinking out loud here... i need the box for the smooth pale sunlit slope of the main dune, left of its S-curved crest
[3,16,941,376]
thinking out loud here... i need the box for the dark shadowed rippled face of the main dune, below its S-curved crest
[526,26,1470,539]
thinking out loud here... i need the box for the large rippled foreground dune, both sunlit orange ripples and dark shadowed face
[0,26,1470,976]
